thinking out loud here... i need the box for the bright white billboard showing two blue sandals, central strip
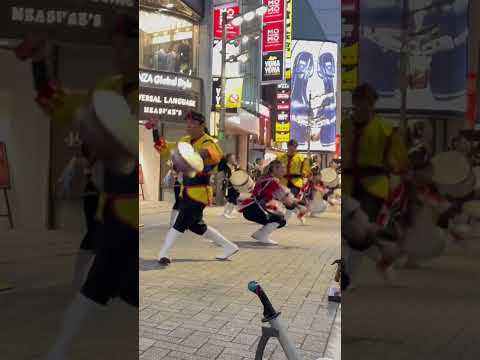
[290,40,338,152]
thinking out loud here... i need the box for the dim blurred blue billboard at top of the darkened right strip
[359,0,469,112]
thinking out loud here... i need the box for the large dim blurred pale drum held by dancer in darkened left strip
[93,90,138,154]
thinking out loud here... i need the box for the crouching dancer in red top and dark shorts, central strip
[239,160,305,245]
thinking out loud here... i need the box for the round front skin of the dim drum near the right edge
[432,151,471,185]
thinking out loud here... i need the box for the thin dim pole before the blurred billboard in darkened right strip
[400,0,409,136]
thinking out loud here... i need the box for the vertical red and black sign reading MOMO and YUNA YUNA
[262,0,286,82]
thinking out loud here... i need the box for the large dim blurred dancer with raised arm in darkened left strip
[24,15,139,360]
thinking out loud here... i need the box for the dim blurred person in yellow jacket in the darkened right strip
[342,84,408,282]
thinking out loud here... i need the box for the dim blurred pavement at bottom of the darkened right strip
[342,232,480,360]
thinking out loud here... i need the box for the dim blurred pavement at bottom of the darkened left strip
[0,231,138,360]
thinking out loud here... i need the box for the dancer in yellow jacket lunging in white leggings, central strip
[155,111,239,266]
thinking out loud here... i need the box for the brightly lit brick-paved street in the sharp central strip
[140,202,341,360]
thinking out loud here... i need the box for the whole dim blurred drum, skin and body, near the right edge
[432,151,476,198]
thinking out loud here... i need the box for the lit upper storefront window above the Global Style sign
[139,10,198,76]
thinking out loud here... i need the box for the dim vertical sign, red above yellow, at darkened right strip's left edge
[342,0,360,91]
